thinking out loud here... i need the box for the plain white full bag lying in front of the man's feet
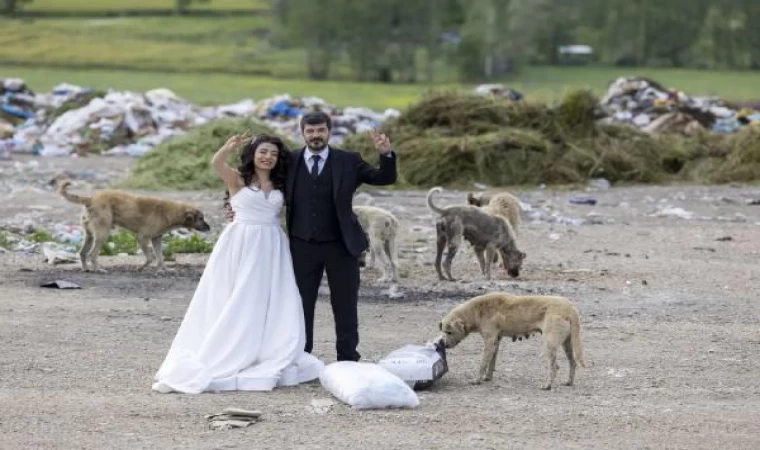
[319,361,420,409]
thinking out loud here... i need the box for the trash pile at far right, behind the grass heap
[600,77,760,135]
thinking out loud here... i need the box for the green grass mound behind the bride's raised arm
[123,118,293,190]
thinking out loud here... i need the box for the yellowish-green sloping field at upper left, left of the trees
[0,15,316,77]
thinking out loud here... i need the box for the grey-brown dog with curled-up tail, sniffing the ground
[427,187,525,281]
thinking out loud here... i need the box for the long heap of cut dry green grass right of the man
[345,90,760,187]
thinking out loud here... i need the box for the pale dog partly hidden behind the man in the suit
[353,205,399,283]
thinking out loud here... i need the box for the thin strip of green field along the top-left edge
[23,0,269,12]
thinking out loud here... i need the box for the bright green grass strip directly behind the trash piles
[0,66,760,109]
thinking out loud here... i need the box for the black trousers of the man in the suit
[290,236,361,361]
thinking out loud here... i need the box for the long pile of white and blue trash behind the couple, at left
[0,78,400,159]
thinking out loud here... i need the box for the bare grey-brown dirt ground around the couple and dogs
[0,158,760,450]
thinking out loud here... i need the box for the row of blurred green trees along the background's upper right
[280,0,760,82]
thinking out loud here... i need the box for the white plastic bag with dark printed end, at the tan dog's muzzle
[378,343,449,390]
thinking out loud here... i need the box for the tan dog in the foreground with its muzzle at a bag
[438,292,586,390]
